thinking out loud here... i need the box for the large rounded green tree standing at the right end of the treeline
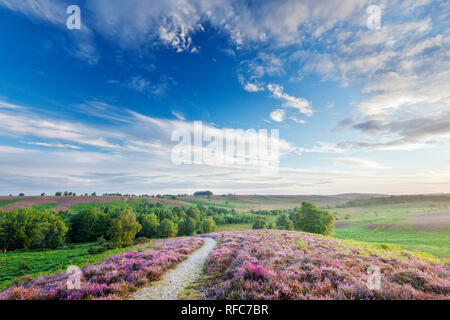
[299,202,335,235]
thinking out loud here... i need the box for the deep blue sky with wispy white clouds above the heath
[0,0,450,195]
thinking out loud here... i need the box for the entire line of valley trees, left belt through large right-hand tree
[0,199,334,251]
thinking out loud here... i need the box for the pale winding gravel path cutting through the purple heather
[133,238,216,300]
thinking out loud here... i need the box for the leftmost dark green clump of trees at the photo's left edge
[0,207,68,250]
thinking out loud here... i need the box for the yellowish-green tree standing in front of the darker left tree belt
[108,209,142,247]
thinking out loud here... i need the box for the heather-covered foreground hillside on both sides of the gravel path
[0,230,450,300]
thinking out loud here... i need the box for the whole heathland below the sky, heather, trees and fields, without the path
[0,194,450,299]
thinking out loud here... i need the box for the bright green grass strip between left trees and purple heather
[0,244,154,291]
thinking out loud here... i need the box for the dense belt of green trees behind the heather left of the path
[0,200,229,251]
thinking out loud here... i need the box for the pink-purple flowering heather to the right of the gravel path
[200,230,450,300]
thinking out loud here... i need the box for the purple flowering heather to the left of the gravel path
[0,237,203,300]
